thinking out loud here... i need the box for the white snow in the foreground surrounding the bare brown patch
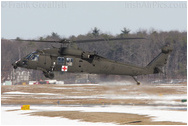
[1,105,187,125]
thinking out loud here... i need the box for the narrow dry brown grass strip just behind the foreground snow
[2,98,152,105]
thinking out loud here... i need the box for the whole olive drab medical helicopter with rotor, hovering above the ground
[12,38,172,85]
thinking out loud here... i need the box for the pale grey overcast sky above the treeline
[1,1,187,39]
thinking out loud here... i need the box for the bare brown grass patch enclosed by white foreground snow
[26,111,186,125]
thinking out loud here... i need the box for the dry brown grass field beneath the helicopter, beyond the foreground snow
[1,85,186,104]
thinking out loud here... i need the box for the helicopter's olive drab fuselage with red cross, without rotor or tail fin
[14,48,149,76]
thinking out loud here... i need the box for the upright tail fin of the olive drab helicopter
[146,44,172,74]
